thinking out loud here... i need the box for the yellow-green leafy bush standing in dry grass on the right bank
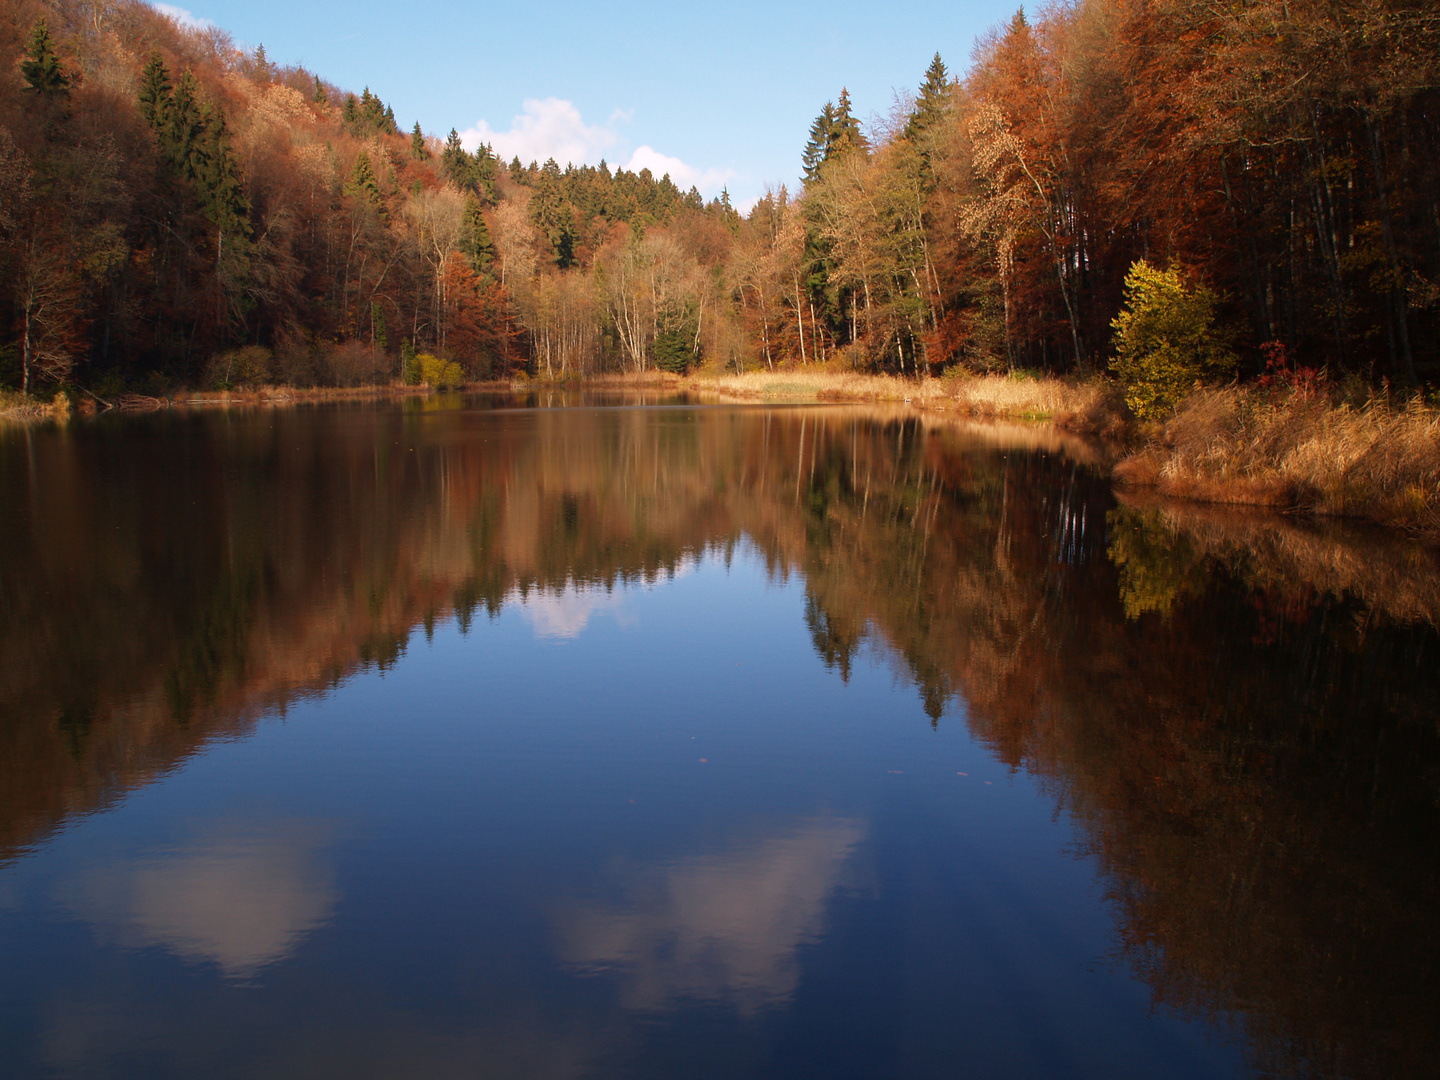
[1110,259,1236,419]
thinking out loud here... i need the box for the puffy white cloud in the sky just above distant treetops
[459,98,736,194]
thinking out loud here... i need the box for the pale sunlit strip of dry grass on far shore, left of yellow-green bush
[687,367,1125,436]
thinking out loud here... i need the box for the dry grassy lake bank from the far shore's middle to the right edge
[676,369,1440,543]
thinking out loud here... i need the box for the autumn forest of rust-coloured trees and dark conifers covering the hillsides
[0,0,1440,397]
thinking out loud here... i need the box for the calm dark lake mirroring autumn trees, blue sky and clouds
[0,399,1440,1080]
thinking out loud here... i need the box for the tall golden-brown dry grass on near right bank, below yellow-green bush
[1115,387,1440,540]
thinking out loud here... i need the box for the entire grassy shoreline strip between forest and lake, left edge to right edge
[8,369,1440,546]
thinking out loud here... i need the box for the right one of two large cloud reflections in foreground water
[557,818,865,1015]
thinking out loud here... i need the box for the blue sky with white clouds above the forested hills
[156,0,1017,204]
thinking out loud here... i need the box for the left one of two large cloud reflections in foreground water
[56,819,337,979]
